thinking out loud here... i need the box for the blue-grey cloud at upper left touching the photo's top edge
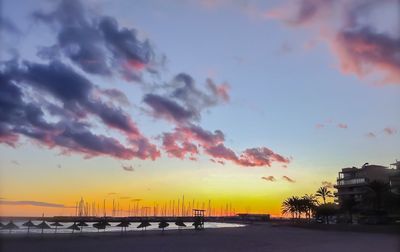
[33,0,157,81]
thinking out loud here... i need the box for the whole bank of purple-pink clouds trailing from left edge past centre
[0,0,289,171]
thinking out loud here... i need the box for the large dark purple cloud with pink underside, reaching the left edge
[0,61,160,160]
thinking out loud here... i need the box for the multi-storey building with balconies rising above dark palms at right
[334,161,400,205]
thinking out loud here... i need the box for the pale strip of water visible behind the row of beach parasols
[0,221,245,236]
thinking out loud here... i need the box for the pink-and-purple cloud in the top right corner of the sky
[266,0,400,84]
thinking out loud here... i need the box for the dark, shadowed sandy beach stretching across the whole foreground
[0,224,400,252]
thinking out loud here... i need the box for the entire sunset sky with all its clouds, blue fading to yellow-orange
[0,0,400,216]
